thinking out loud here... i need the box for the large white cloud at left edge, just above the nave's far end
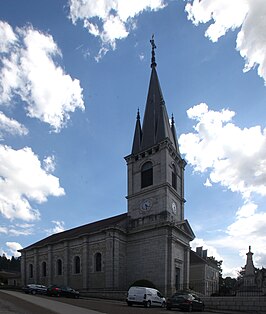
[0,145,64,221]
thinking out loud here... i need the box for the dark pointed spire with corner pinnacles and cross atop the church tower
[132,36,178,154]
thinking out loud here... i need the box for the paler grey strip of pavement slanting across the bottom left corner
[1,290,103,314]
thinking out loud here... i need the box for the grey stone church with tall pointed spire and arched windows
[19,39,195,296]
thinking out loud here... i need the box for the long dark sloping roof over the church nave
[18,213,127,252]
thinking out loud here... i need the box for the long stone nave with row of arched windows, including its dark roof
[21,214,126,290]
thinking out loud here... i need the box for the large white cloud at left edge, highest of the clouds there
[0,23,84,132]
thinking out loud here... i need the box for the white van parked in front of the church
[127,286,165,307]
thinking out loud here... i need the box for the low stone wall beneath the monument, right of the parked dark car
[202,296,266,314]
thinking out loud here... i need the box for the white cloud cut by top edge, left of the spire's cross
[69,0,165,60]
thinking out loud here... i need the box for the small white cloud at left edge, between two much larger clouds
[0,111,28,139]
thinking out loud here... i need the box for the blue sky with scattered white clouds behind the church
[0,0,266,277]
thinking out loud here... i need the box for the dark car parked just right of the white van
[166,292,204,312]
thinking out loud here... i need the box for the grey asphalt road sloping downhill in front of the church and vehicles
[0,290,249,314]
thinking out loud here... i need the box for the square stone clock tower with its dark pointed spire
[125,37,186,227]
